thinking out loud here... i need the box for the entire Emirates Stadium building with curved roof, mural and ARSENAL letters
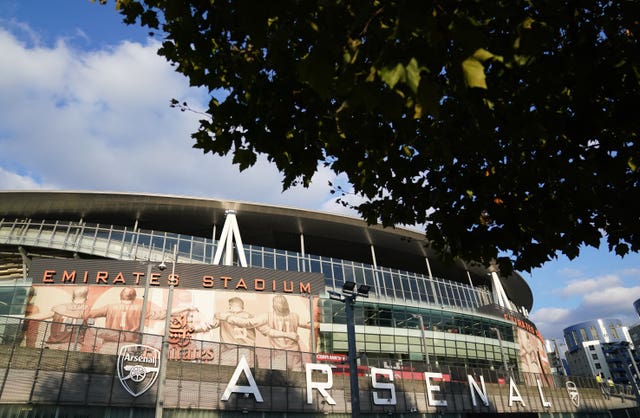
[0,191,633,417]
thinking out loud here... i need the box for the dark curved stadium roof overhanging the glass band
[0,191,533,310]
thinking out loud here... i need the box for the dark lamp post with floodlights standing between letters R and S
[327,282,371,417]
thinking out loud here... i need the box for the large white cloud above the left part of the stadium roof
[0,22,341,211]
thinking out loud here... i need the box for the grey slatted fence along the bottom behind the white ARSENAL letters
[0,317,635,416]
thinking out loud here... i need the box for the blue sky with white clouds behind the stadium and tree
[0,0,640,338]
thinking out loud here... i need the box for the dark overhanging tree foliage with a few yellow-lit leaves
[101,0,640,271]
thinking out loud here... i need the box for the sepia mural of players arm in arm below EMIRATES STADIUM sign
[24,286,317,367]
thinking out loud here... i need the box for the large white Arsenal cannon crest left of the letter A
[118,344,160,396]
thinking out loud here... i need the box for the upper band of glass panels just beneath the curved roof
[0,219,493,311]
